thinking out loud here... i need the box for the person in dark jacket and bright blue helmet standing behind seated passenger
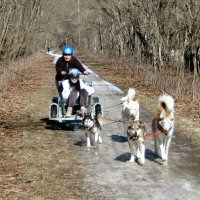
[55,46,88,95]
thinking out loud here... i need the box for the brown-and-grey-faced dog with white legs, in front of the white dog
[127,120,146,165]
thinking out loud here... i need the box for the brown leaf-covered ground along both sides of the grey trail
[0,53,200,200]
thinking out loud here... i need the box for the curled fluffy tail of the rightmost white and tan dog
[158,94,175,113]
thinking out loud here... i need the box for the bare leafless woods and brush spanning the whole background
[0,0,200,101]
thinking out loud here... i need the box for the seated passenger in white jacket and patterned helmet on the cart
[62,68,94,117]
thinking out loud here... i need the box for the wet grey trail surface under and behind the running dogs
[73,66,200,200]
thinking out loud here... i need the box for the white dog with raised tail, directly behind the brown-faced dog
[121,88,140,136]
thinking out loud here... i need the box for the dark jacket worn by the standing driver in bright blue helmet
[55,56,86,81]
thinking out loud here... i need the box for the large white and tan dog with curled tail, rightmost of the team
[152,94,175,162]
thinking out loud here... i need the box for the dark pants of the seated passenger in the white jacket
[68,89,88,107]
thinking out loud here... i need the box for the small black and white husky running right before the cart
[83,114,103,148]
